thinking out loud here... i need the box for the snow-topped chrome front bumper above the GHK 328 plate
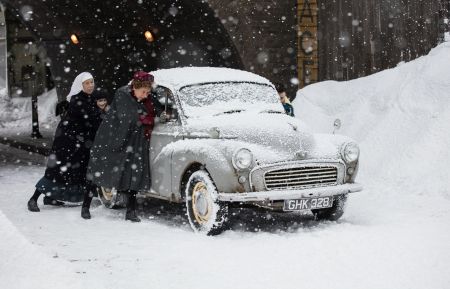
[218,183,363,202]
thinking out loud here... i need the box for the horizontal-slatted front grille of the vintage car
[264,166,338,190]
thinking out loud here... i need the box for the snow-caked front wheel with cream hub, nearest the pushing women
[185,170,228,236]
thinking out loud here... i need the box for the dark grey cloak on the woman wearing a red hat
[88,86,160,191]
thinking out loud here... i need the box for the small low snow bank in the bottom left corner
[0,211,83,289]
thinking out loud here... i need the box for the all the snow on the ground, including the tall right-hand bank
[0,43,450,289]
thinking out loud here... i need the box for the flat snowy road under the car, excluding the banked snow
[0,146,450,289]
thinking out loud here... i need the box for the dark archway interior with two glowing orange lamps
[0,0,243,99]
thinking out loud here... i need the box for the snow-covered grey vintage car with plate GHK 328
[100,67,362,234]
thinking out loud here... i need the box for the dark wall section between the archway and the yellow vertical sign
[208,0,298,96]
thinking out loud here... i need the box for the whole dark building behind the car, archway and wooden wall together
[0,0,448,97]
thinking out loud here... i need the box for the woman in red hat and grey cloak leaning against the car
[81,71,164,222]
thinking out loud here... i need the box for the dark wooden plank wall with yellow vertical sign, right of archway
[207,0,442,92]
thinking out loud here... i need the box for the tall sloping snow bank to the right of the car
[293,42,450,198]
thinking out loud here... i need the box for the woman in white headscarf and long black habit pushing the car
[28,72,101,212]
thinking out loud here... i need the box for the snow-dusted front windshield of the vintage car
[180,82,283,118]
